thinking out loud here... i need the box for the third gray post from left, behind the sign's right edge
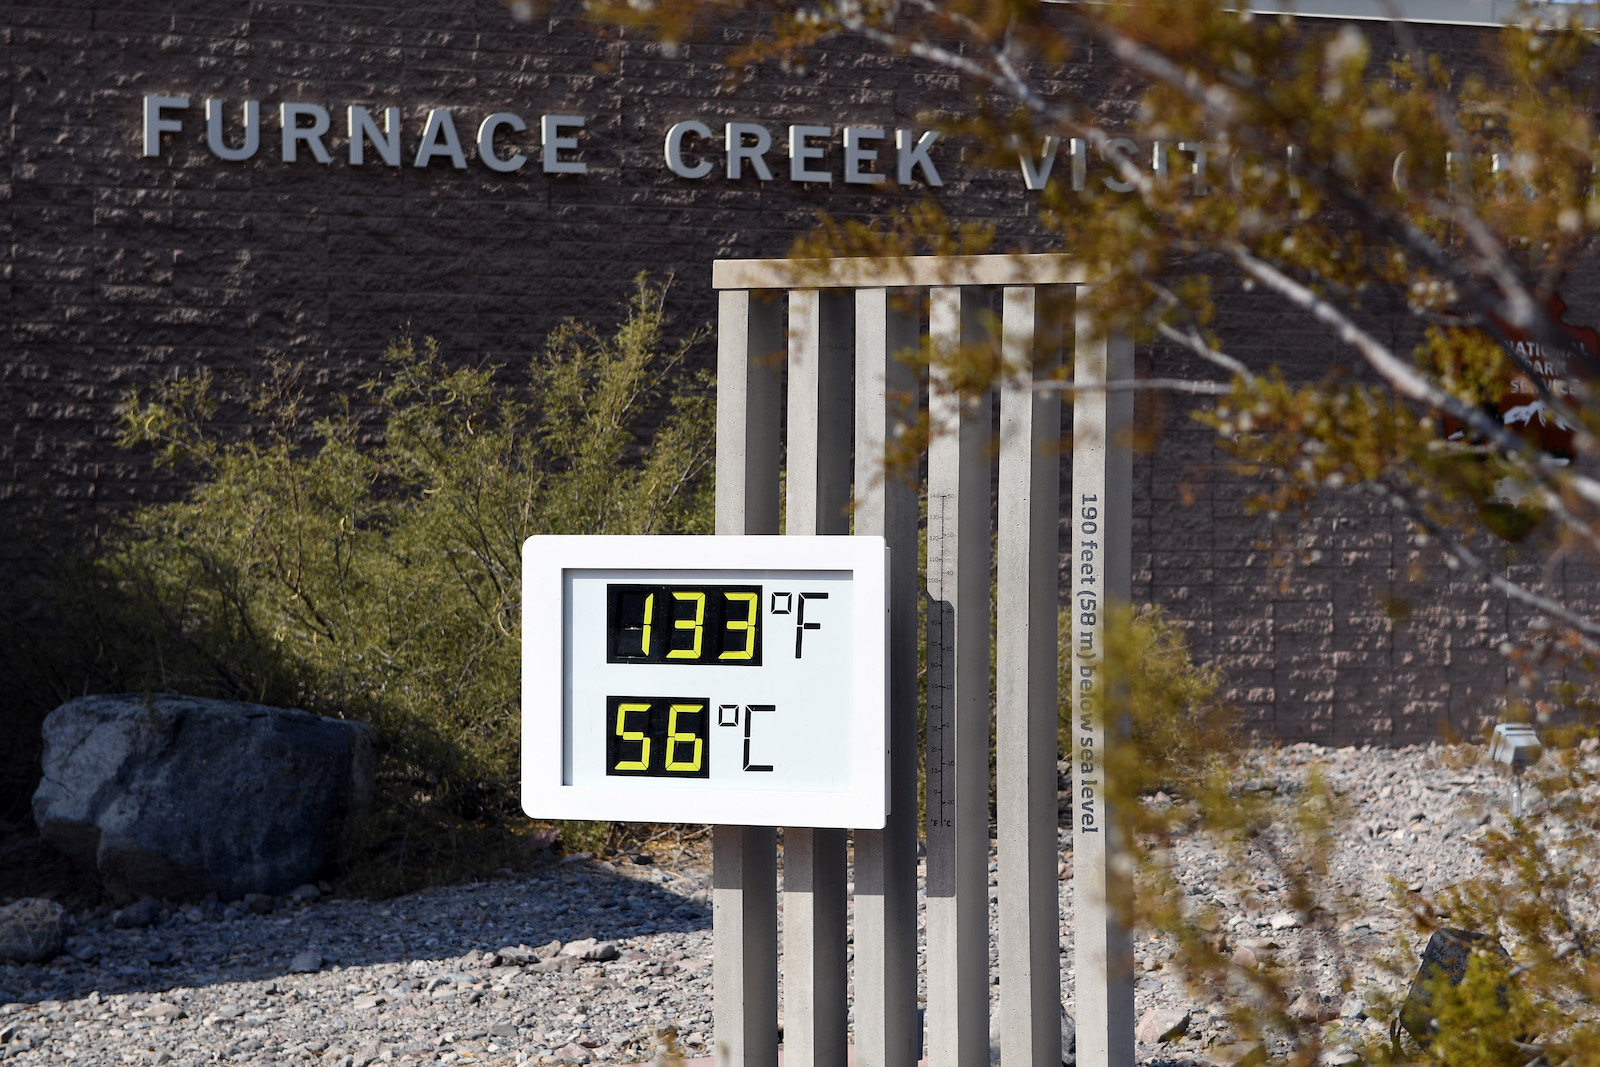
[856,290,920,1067]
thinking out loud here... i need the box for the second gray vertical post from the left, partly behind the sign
[784,290,853,1067]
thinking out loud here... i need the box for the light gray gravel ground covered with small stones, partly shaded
[0,745,1600,1067]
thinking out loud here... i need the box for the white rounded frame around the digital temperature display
[522,536,890,830]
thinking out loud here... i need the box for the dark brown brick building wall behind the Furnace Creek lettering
[0,0,1600,744]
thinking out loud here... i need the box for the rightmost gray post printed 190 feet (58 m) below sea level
[1066,303,1133,1067]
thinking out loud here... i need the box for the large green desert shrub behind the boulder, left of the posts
[0,275,714,878]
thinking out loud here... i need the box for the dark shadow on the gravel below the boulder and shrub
[0,862,710,1005]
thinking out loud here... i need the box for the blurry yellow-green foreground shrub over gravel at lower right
[1062,613,1600,1067]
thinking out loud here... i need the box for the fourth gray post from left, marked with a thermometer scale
[926,286,990,1067]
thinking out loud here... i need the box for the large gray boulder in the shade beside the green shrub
[34,694,379,901]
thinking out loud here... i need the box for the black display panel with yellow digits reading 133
[605,584,762,667]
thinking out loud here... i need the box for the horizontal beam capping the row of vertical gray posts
[710,253,1088,290]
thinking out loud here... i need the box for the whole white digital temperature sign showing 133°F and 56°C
[522,536,888,829]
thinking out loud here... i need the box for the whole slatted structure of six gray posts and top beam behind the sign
[712,256,1133,1067]
